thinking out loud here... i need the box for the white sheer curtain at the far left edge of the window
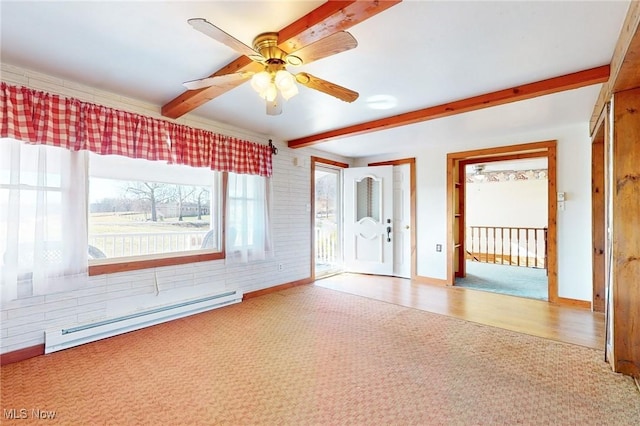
[0,139,88,300]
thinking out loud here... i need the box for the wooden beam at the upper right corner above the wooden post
[590,1,640,137]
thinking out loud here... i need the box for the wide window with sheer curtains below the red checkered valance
[0,139,272,294]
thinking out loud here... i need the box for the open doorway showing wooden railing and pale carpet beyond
[455,157,548,300]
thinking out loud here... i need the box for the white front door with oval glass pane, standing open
[343,166,394,275]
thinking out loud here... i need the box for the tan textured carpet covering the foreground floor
[1,286,640,425]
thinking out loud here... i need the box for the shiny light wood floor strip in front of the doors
[314,274,605,350]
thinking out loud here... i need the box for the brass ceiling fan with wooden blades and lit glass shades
[184,18,358,115]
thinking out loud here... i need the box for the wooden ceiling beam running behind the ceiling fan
[162,0,402,118]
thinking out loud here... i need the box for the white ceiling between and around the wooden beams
[0,0,629,157]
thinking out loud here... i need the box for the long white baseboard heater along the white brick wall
[44,291,242,354]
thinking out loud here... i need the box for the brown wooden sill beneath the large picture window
[89,251,225,276]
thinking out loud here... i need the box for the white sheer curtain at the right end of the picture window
[225,173,273,263]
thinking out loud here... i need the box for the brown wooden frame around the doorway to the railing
[446,140,556,304]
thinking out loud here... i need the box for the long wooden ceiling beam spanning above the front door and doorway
[288,65,609,148]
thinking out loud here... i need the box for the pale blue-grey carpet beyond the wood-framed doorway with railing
[455,261,549,300]
